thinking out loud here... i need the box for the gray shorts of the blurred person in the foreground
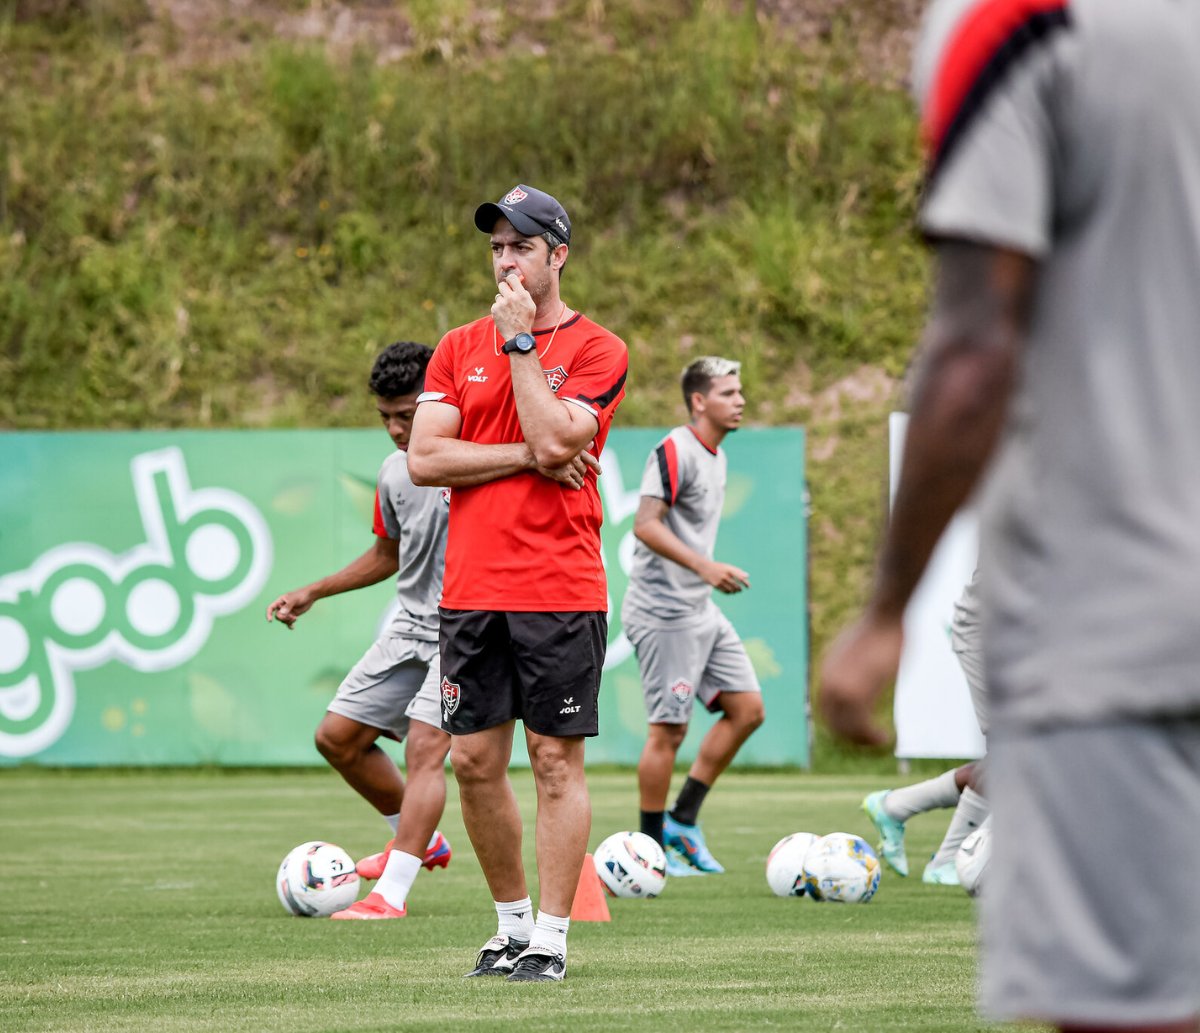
[980,715,1200,1026]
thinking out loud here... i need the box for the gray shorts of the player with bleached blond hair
[625,606,762,725]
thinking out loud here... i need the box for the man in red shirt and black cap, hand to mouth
[409,185,628,981]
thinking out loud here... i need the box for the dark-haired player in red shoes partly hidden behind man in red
[266,341,450,919]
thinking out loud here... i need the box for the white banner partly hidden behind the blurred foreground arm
[888,413,986,758]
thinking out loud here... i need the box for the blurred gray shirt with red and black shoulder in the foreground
[914,0,1200,727]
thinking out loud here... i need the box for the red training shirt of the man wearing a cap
[418,313,629,612]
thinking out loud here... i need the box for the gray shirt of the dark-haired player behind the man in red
[373,450,450,642]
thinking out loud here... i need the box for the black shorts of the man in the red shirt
[440,608,608,738]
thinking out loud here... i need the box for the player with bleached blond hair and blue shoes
[620,356,763,876]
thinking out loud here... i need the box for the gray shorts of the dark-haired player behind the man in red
[329,633,442,741]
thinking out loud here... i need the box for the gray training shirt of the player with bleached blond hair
[620,425,726,626]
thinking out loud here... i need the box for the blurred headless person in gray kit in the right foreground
[821,0,1200,1033]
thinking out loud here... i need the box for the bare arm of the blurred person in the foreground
[820,241,1036,745]
